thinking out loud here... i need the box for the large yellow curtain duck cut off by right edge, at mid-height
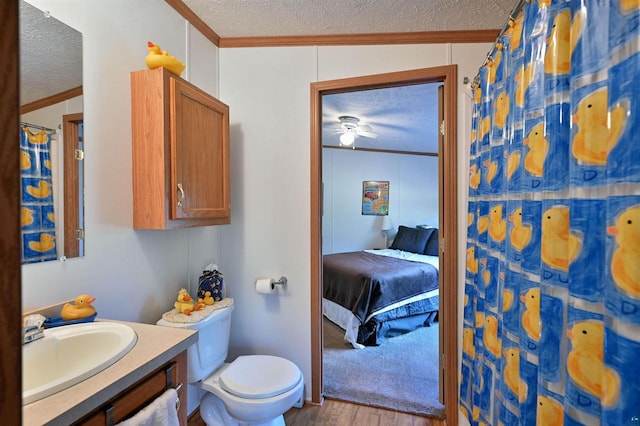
[607,206,640,299]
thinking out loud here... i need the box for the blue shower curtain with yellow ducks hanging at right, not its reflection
[460,0,640,425]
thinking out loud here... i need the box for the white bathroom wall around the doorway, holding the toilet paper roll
[219,44,490,406]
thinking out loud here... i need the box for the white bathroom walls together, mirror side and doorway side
[22,0,489,410]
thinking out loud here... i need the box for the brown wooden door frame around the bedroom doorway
[310,65,458,425]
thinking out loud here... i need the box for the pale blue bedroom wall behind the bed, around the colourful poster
[322,148,438,254]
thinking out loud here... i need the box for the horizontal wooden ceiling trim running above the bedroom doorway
[220,29,500,48]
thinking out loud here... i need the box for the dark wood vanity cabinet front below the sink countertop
[74,351,187,426]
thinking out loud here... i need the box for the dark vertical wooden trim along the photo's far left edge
[0,0,22,425]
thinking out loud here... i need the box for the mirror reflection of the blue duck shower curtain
[20,127,57,263]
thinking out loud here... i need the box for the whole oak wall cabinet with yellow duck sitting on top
[131,68,231,229]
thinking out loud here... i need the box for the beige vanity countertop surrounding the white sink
[22,320,198,426]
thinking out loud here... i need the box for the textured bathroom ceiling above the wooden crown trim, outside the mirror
[183,0,516,38]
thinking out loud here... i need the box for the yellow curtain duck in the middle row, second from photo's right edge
[540,206,582,272]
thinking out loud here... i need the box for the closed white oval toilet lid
[219,355,302,399]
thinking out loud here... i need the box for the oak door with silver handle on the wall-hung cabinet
[170,78,230,223]
